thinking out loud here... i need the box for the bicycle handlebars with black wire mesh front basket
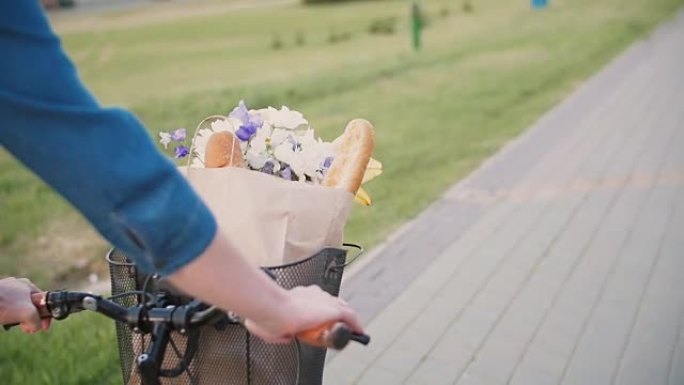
[5,244,370,385]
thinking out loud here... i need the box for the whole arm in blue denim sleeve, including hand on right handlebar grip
[0,1,361,341]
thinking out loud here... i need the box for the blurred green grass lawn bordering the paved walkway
[0,0,684,384]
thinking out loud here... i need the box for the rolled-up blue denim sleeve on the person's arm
[0,0,216,275]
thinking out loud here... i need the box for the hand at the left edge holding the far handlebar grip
[0,277,50,333]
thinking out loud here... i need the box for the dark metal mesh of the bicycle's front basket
[108,249,346,385]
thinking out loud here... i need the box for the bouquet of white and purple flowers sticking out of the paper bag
[159,101,382,206]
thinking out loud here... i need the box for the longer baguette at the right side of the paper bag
[323,119,375,194]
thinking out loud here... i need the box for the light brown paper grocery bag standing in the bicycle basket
[181,167,353,266]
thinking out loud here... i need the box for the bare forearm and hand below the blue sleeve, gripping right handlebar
[169,228,363,342]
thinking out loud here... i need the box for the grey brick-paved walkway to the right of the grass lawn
[324,8,684,385]
